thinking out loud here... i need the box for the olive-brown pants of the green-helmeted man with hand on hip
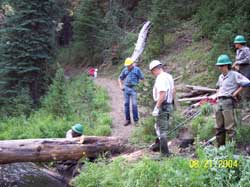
[216,98,236,146]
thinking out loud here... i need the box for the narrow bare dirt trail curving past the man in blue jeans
[95,77,134,140]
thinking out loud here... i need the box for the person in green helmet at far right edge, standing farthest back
[232,35,250,109]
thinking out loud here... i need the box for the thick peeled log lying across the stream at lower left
[0,136,124,164]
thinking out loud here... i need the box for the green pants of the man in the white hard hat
[156,104,172,155]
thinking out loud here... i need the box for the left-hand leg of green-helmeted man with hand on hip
[215,106,226,147]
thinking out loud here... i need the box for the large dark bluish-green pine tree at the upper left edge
[0,0,58,111]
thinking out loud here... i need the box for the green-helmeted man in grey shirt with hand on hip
[216,54,250,147]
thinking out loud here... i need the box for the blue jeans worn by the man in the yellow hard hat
[124,87,139,122]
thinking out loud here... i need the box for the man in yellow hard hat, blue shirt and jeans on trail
[118,58,144,126]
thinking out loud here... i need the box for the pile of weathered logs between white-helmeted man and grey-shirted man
[178,85,216,107]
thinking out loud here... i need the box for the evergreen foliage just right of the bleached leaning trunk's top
[144,0,200,58]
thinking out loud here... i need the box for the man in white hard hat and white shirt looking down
[149,60,174,156]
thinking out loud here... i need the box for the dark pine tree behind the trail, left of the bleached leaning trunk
[73,0,104,61]
